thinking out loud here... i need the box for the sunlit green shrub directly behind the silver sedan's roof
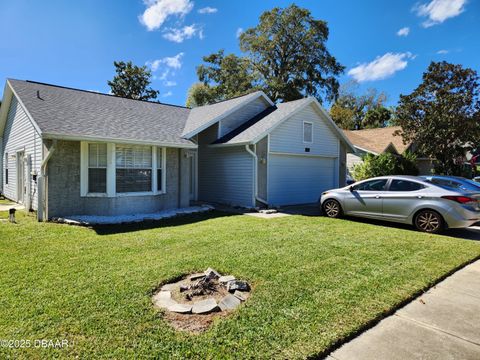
[353,152,418,181]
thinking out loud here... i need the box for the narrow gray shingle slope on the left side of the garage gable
[215,98,311,145]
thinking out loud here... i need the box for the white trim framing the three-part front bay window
[80,141,167,198]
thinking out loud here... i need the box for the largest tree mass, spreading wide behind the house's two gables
[186,5,344,102]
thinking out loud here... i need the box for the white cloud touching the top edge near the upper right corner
[413,0,467,27]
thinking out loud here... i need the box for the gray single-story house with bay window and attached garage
[0,79,354,220]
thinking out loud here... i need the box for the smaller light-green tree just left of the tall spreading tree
[187,50,256,107]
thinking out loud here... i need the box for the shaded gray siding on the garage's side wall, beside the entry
[198,125,254,207]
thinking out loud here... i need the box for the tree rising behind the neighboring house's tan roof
[330,82,390,130]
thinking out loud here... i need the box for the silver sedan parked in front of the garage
[320,176,480,233]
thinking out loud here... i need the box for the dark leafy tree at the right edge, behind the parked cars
[396,61,480,175]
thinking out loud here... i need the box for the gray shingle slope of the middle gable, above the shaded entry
[182,91,268,137]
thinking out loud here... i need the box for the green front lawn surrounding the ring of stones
[0,212,480,359]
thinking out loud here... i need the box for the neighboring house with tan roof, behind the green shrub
[344,126,433,175]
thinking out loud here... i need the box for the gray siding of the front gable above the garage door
[270,105,339,157]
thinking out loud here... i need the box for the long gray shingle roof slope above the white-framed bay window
[8,79,194,146]
